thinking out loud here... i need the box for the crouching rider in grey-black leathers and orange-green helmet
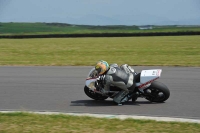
[95,60,135,105]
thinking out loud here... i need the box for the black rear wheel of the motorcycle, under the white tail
[144,81,170,103]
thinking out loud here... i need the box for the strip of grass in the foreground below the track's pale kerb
[0,113,200,133]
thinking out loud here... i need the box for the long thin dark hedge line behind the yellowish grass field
[0,31,200,39]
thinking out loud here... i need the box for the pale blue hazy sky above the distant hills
[0,0,200,25]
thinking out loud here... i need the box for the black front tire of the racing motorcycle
[84,86,108,100]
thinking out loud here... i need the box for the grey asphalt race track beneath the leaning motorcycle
[0,66,200,119]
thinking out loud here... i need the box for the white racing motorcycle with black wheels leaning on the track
[84,66,170,103]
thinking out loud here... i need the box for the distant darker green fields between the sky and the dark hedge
[0,23,200,35]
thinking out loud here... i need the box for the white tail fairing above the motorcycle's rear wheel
[140,69,162,84]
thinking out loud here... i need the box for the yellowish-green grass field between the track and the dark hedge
[0,36,200,66]
